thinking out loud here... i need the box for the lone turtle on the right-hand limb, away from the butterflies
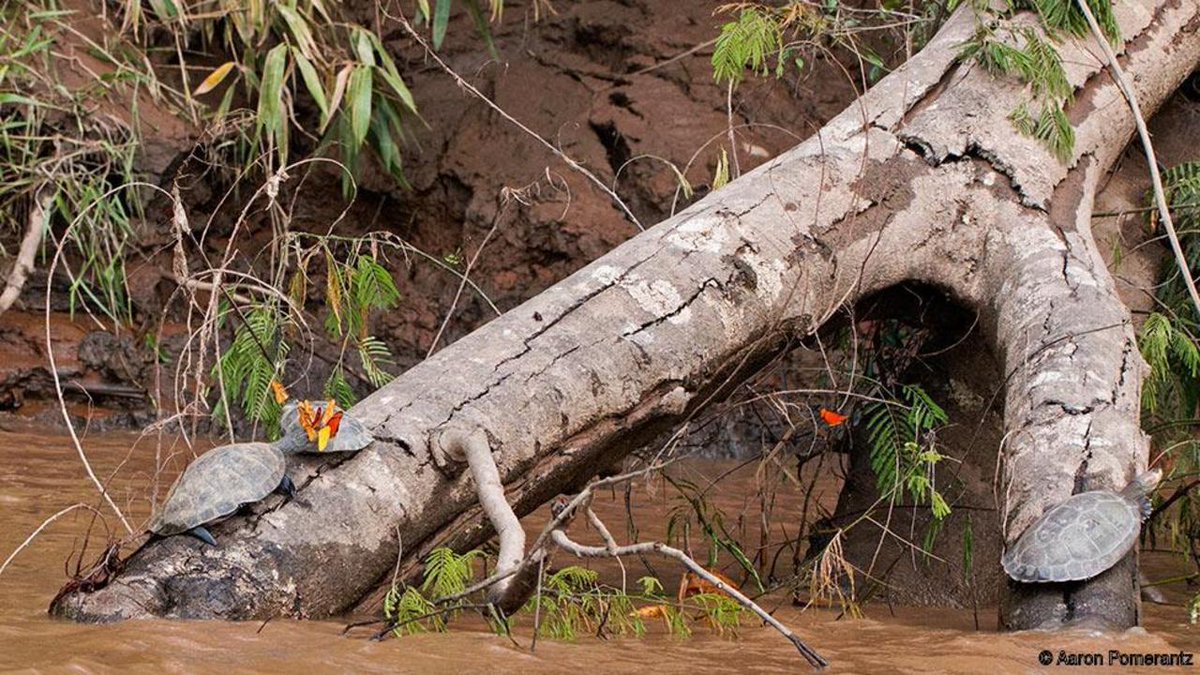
[1001,468,1163,584]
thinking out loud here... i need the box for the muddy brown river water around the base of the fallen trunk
[0,428,1200,674]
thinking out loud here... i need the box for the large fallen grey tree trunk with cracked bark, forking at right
[53,0,1200,628]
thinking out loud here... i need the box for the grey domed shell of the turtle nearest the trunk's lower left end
[150,443,287,536]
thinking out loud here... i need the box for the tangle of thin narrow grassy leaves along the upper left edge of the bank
[0,0,149,323]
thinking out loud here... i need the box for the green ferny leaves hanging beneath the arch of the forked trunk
[863,384,950,520]
